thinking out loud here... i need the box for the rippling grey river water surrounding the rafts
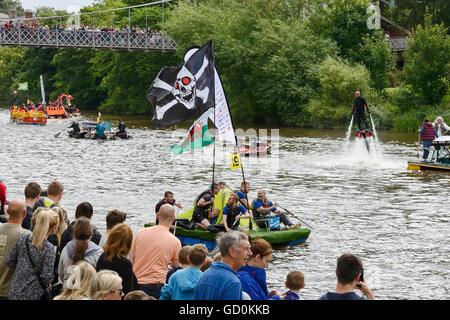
[0,109,450,299]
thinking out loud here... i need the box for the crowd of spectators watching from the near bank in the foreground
[0,181,374,300]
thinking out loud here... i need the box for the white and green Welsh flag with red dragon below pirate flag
[170,109,214,155]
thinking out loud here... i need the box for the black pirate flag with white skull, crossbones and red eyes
[147,40,215,129]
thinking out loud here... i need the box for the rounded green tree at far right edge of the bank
[404,13,450,104]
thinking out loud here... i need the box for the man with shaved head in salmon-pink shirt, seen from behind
[130,204,181,299]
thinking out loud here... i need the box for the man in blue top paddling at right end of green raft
[251,189,294,228]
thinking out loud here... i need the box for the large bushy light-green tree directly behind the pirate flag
[167,1,336,125]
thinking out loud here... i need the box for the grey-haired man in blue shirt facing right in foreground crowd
[194,231,252,300]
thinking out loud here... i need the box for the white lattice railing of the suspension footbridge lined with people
[0,28,176,51]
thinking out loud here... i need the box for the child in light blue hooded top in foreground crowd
[159,244,208,300]
